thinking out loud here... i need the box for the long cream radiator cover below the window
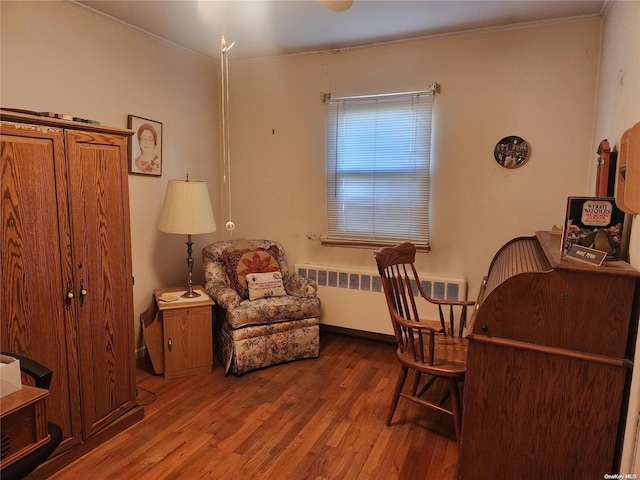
[294,263,467,335]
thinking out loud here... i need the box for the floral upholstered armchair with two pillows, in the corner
[202,240,320,375]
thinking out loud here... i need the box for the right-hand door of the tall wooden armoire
[67,131,135,436]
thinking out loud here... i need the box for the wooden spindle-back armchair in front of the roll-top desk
[374,242,475,441]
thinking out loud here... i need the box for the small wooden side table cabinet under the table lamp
[143,285,214,379]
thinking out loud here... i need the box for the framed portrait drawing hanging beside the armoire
[127,115,162,177]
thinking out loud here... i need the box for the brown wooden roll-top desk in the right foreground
[458,232,640,480]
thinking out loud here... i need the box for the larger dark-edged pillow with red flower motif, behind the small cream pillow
[222,245,280,300]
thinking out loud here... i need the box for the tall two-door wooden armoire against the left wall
[0,110,144,476]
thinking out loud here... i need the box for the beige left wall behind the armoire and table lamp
[0,1,221,354]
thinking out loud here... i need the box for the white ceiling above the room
[77,0,605,60]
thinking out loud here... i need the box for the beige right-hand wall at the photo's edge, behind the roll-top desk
[590,1,640,474]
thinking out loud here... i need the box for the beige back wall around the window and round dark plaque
[229,19,600,316]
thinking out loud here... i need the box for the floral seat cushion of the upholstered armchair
[226,295,320,330]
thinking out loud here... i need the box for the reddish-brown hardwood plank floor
[51,332,458,480]
